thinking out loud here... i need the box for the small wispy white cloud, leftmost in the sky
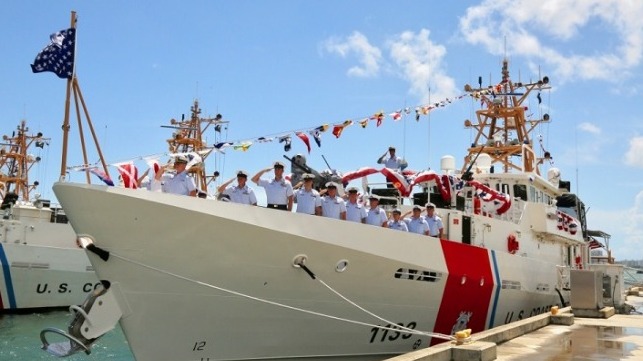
[323,31,382,77]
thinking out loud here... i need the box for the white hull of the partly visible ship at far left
[0,205,98,313]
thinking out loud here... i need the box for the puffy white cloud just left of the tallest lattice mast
[388,29,456,101]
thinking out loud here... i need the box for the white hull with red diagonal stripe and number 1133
[54,183,568,361]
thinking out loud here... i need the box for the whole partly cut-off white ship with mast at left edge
[0,121,99,313]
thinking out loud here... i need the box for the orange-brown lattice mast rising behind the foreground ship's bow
[167,100,228,193]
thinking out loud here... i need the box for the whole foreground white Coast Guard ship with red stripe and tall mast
[54,61,612,361]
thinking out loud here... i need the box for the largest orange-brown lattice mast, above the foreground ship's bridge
[462,58,550,174]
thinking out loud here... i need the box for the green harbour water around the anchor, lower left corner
[0,310,134,361]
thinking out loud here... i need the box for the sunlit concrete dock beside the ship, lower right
[388,289,643,361]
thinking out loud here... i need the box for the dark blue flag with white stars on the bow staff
[31,28,76,79]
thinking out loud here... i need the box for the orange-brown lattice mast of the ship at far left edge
[0,120,50,200]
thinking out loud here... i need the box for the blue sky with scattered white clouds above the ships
[0,0,643,260]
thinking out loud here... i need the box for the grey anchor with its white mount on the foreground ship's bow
[40,280,122,357]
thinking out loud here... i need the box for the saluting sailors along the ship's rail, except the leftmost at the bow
[218,162,444,238]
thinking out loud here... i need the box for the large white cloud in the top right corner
[460,0,643,80]
